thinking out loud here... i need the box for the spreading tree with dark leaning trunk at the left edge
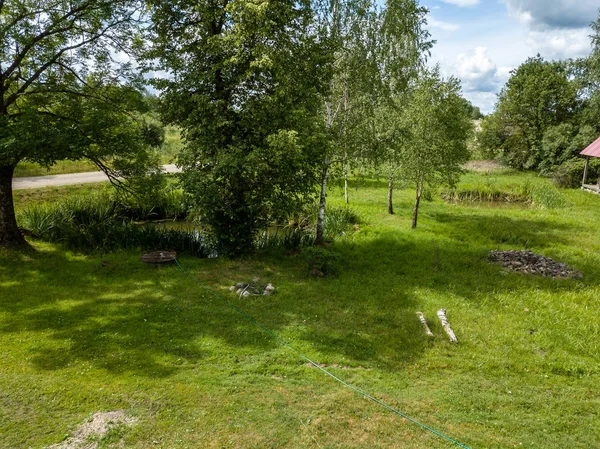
[0,0,147,246]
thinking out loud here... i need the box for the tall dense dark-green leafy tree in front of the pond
[148,0,329,256]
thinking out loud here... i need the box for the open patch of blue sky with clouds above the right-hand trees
[421,0,600,113]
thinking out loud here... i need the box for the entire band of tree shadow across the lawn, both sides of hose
[0,205,597,377]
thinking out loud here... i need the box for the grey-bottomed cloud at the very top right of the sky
[504,0,600,29]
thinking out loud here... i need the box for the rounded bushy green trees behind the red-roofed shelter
[477,17,600,174]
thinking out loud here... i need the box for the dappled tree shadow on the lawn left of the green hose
[0,251,272,377]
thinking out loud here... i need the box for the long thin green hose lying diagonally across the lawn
[175,259,470,449]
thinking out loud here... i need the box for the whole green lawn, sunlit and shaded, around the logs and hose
[0,172,600,449]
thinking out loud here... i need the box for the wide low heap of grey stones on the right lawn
[489,250,583,278]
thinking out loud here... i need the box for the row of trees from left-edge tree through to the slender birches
[0,0,474,256]
